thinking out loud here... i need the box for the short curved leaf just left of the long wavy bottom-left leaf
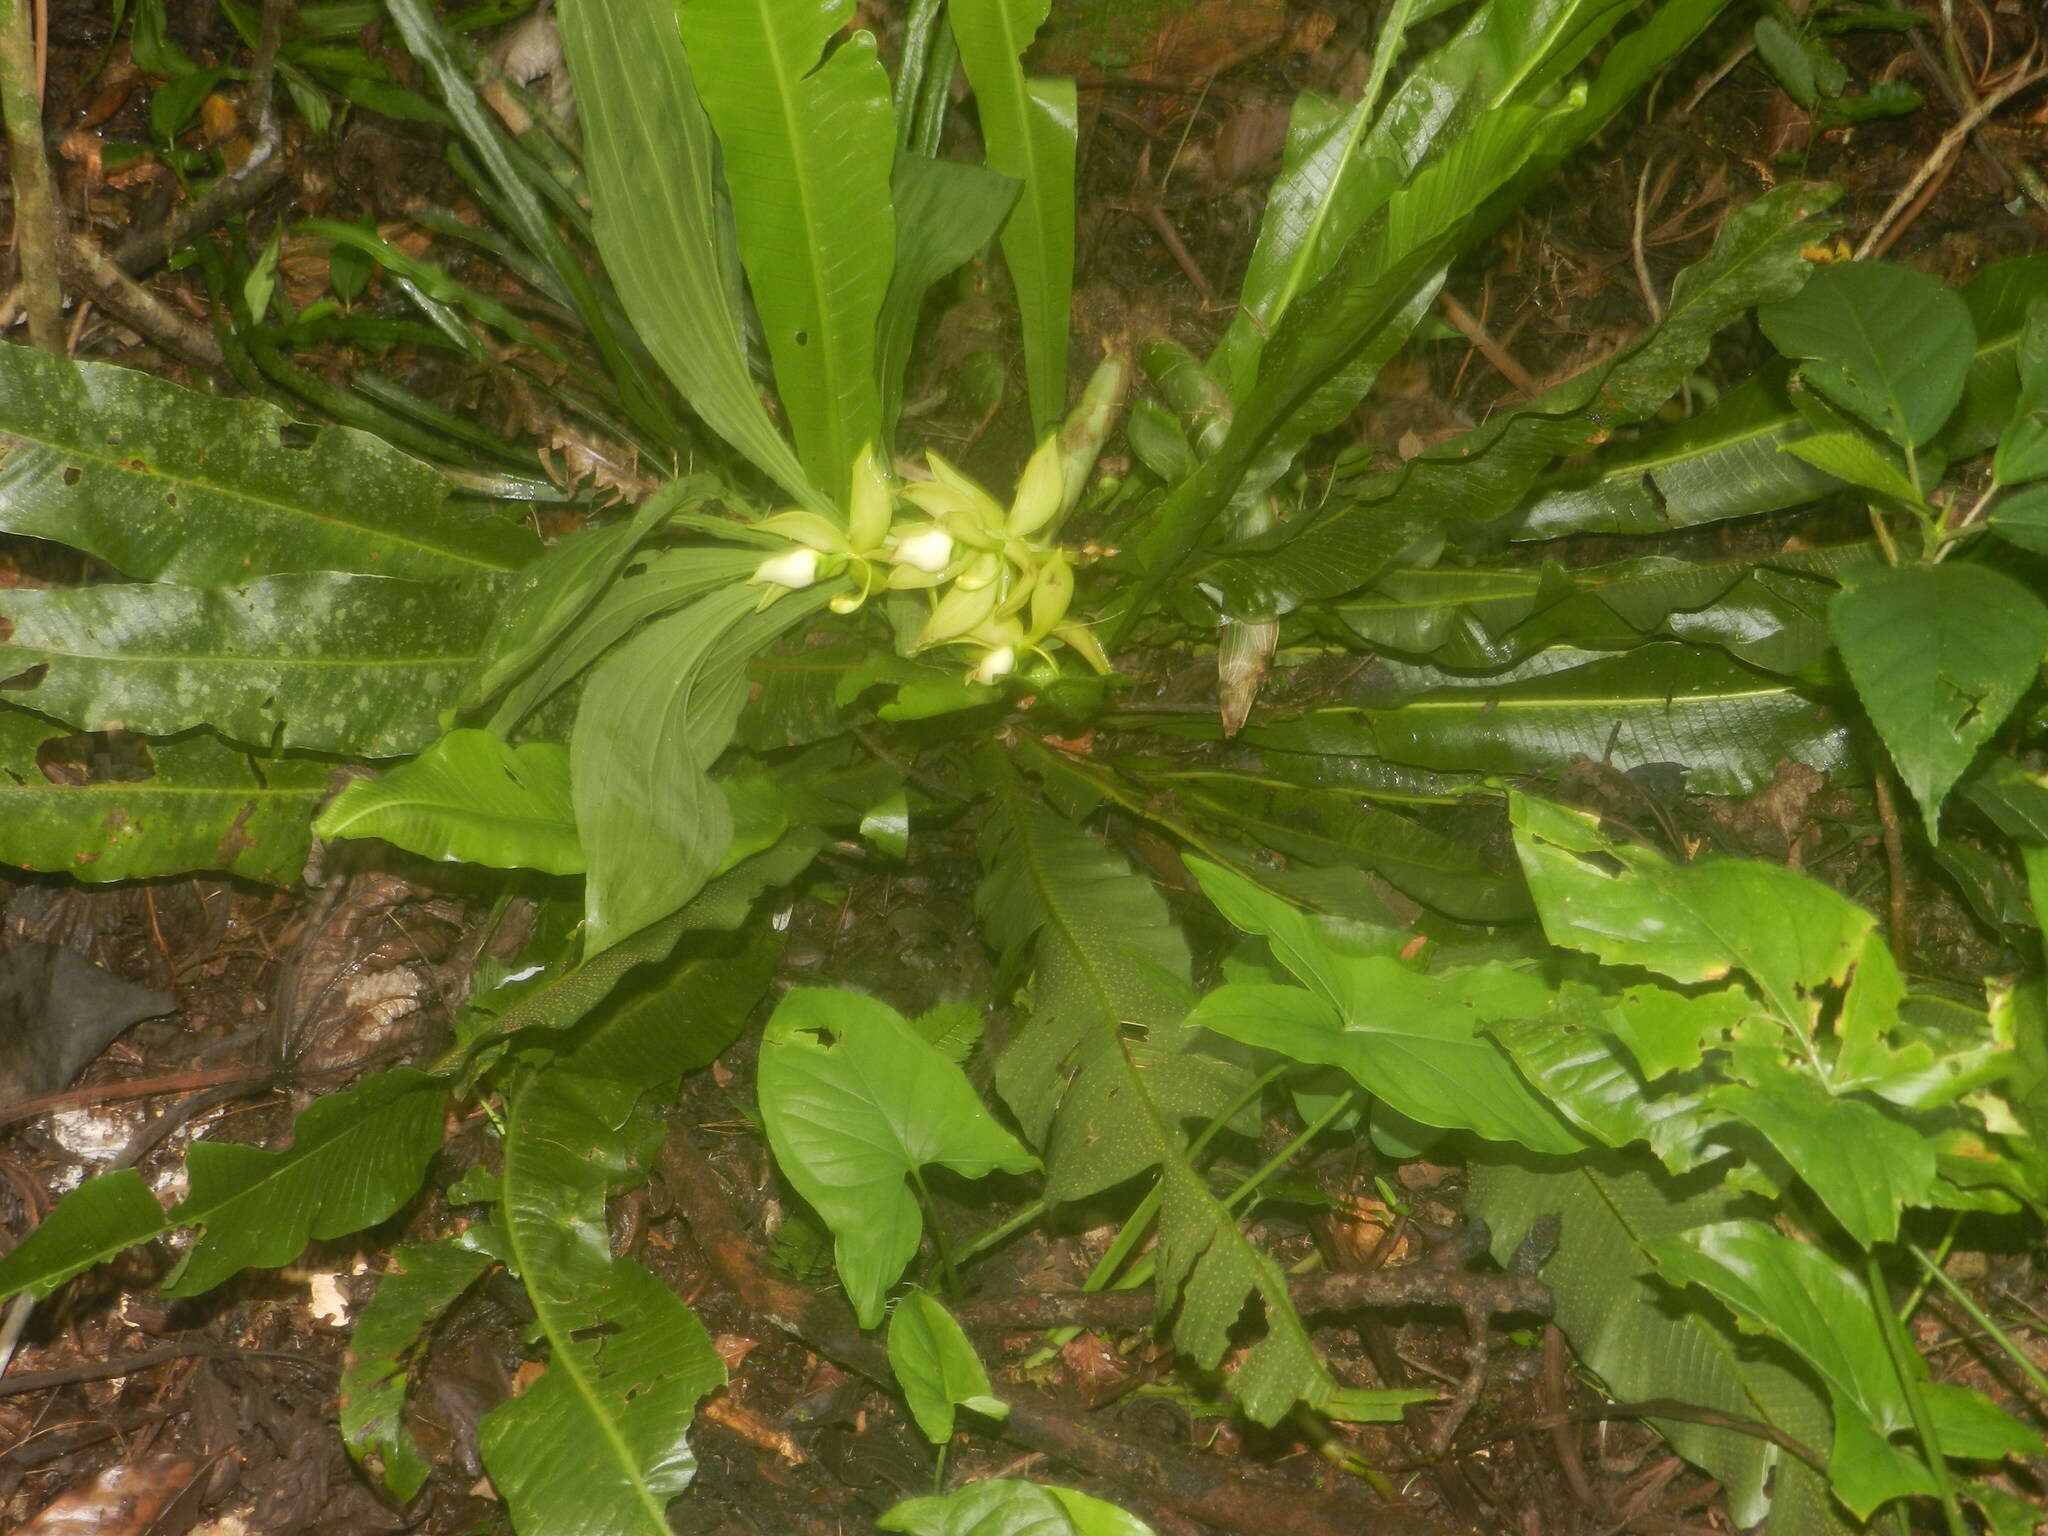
[340,1239,492,1503]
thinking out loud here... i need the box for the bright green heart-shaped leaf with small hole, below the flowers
[758,987,1038,1327]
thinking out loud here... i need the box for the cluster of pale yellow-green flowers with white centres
[752,438,1108,682]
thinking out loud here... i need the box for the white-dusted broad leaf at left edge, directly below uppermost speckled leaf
[0,571,495,758]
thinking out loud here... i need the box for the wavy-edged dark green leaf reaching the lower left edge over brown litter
[0,1067,446,1298]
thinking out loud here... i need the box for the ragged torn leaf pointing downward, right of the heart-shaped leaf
[977,758,1337,1423]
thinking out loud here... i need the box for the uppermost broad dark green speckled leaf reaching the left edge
[0,346,539,586]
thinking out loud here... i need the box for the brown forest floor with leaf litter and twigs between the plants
[0,0,2048,1536]
